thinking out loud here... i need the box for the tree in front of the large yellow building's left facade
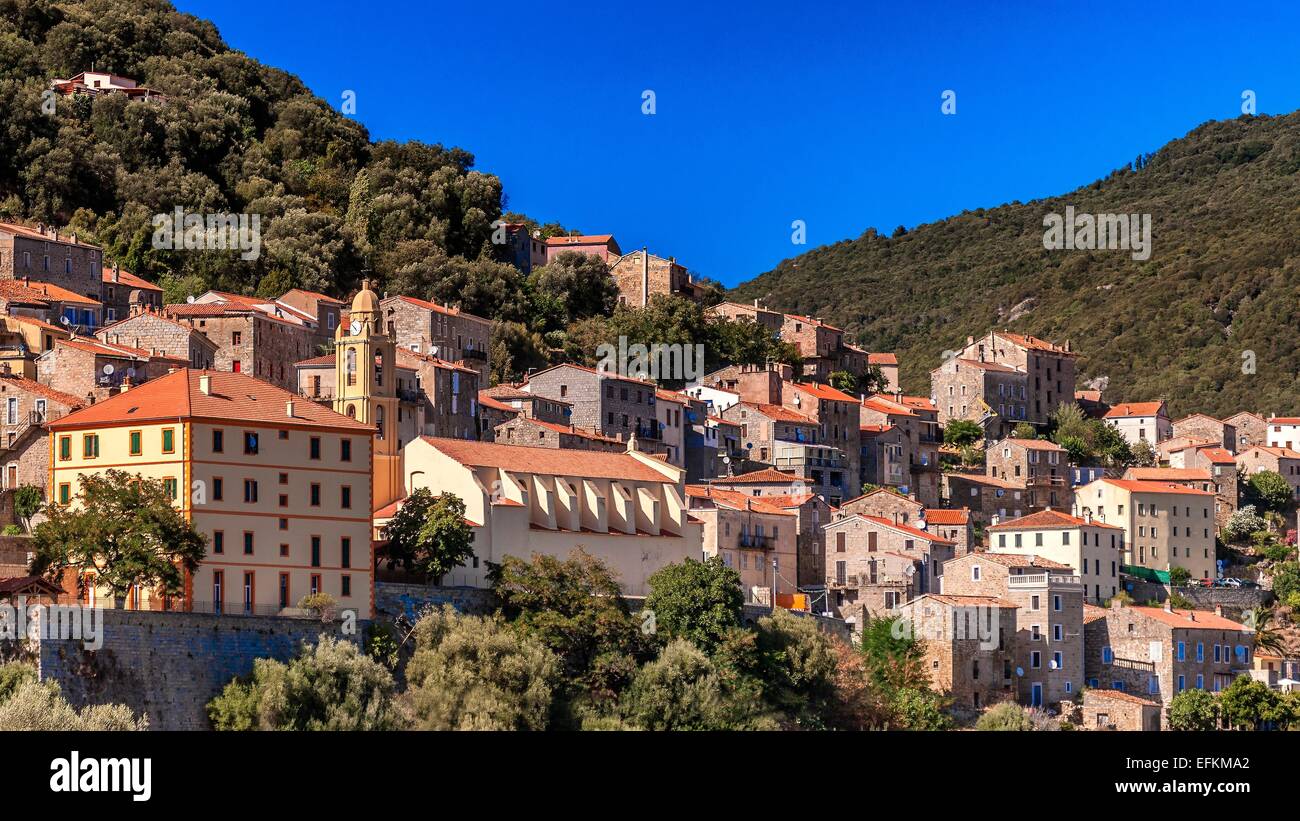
[31,470,207,599]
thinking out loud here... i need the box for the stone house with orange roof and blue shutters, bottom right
[1084,604,1252,726]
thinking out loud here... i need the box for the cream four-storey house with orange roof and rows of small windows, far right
[1073,478,1217,581]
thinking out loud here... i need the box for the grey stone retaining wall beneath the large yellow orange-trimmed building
[36,611,365,730]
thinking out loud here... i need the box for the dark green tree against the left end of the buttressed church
[385,487,475,583]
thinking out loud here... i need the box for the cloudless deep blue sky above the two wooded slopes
[176,0,1300,284]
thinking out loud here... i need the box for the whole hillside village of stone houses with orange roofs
[0,189,1300,729]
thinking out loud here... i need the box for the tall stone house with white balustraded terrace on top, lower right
[944,551,1084,707]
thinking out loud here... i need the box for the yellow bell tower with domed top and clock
[334,279,404,509]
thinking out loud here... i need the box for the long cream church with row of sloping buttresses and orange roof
[387,436,703,596]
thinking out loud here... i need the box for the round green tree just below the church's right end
[646,556,745,652]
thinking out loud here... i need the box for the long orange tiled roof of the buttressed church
[420,436,672,482]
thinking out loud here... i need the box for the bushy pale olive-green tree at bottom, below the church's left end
[399,605,562,730]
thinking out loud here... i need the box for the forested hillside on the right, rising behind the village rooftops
[733,114,1300,414]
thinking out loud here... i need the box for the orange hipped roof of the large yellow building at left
[49,368,374,433]
